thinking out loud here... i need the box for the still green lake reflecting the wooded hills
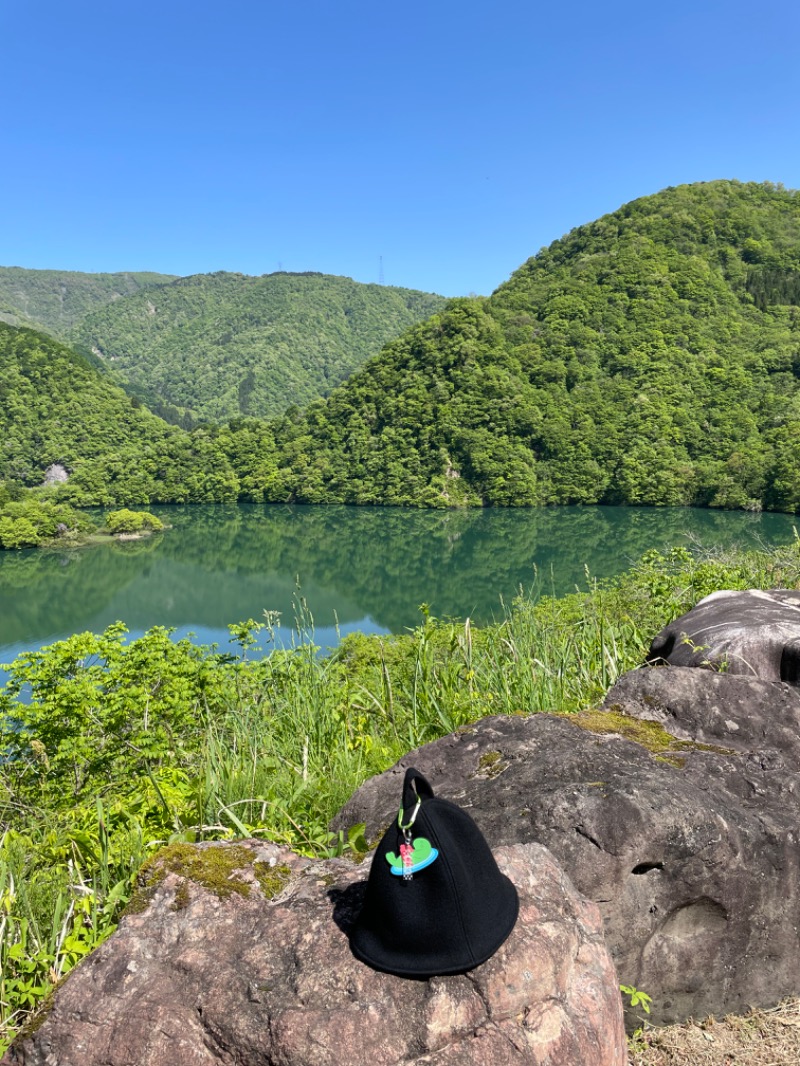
[0,504,797,680]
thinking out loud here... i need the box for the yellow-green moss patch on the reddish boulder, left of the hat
[125,844,253,915]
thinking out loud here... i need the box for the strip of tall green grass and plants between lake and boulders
[0,545,800,1048]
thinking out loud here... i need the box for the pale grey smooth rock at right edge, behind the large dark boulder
[647,588,800,684]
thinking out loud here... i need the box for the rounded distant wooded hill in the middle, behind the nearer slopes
[71,273,445,421]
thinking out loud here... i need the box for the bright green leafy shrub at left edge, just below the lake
[0,624,223,818]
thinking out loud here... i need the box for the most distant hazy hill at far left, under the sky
[0,267,175,339]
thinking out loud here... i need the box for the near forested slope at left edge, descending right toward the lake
[0,323,239,504]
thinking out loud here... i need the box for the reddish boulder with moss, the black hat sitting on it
[2,841,626,1066]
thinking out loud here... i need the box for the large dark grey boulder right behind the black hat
[334,686,800,1023]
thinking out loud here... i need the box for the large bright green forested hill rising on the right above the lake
[261,181,800,511]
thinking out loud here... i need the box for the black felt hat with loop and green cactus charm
[350,768,519,978]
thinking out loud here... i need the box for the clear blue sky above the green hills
[0,0,800,295]
